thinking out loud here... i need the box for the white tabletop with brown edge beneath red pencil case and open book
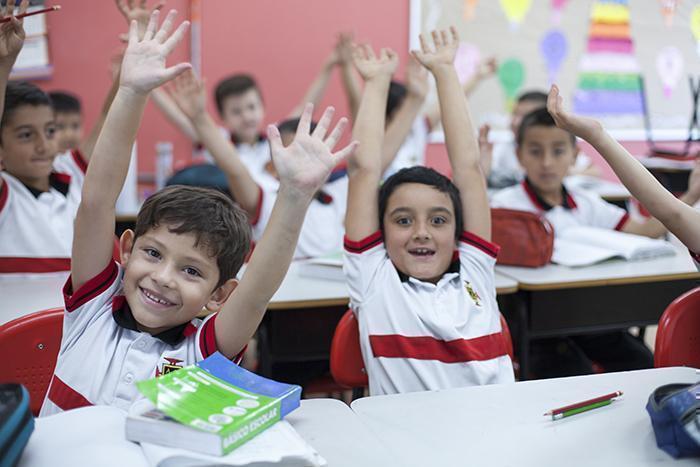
[496,248,700,290]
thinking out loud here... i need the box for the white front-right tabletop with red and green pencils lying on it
[352,368,700,467]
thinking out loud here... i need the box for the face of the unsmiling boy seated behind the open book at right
[516,126,578,193]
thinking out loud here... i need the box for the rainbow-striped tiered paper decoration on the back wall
[573,0,643,117]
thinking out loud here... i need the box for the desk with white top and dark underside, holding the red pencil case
[496,248,700,378]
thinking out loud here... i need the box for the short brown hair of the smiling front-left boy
[134,185,251,287]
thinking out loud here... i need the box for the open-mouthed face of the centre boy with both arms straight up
[384,183,456,283]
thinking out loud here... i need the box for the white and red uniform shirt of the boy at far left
[0,150,87,278]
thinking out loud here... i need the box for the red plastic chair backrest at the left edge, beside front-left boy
[0,308,63,415]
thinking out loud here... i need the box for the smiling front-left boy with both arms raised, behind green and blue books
[41,10,355,415]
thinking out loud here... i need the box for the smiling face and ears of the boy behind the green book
[121,225,236,334]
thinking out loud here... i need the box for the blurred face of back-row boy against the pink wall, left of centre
[221,89,265,141]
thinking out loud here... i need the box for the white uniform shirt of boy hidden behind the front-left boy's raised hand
[251,176,348,259]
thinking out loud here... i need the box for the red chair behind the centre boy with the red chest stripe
[331,310,513,400]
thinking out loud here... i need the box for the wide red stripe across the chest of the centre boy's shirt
[369,332,508,363]
